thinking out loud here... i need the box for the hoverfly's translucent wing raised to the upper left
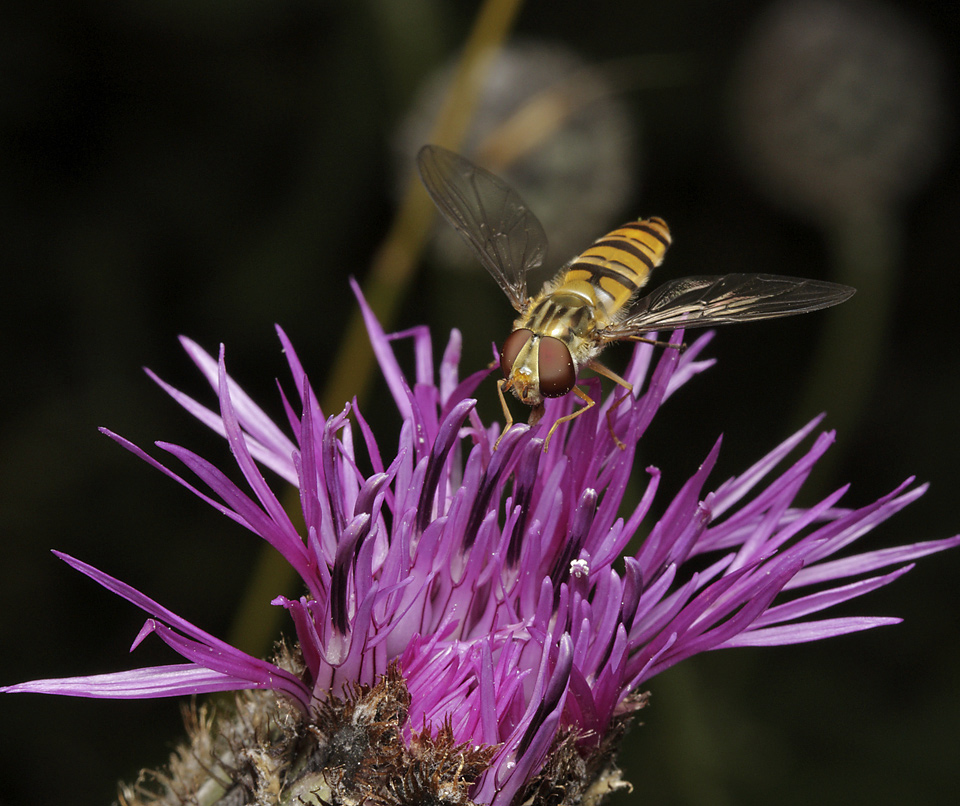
[417,146,547,311]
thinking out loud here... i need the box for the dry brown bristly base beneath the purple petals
[119,652,632,806]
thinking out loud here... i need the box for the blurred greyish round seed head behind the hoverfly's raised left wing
[395,41,639,272]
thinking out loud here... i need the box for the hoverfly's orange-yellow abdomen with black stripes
[554,218,670,320]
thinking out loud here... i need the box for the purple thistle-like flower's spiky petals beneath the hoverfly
[2,286,960,806]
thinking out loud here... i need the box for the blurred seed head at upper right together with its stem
[733,0,947,460]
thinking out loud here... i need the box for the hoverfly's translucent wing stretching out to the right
[599,274,855,341]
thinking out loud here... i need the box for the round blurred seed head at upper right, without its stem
[735,0,944,221]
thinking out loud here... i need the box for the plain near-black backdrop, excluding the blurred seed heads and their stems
[0,0,960,806]
